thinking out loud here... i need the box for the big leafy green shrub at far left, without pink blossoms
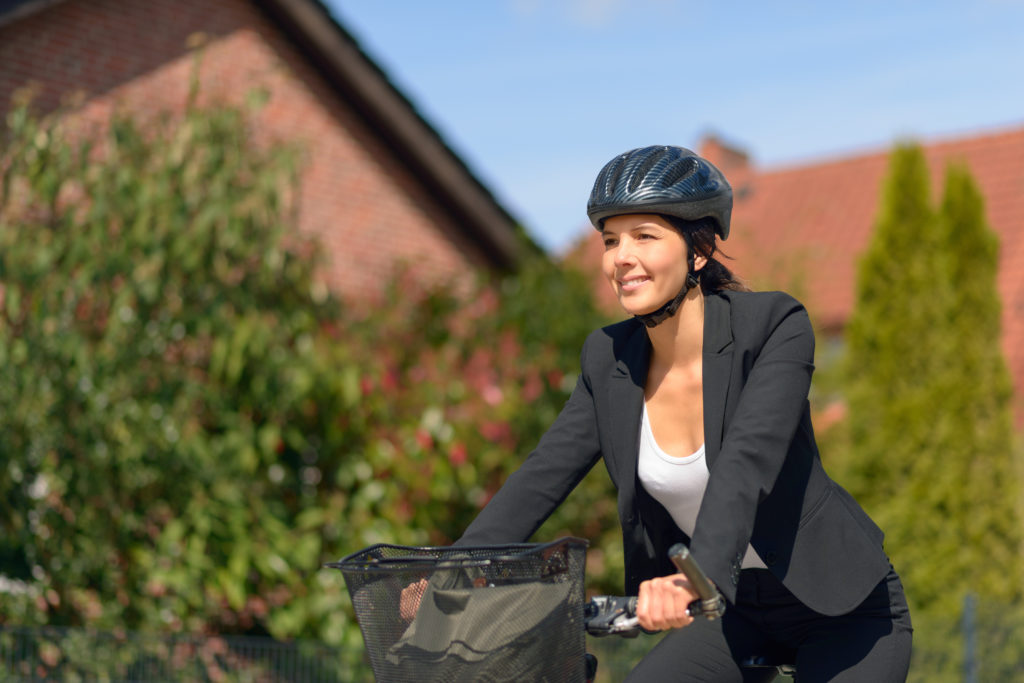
[0,94,354,647]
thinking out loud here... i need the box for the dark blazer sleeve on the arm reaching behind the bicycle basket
[455,344,601,546]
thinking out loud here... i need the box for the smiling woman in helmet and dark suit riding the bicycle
[458,146,911,682]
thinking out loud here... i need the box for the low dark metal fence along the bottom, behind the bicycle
[0,597,1024,683]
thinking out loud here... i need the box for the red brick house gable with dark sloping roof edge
[0,0,529,298]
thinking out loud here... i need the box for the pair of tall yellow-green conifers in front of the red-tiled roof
[839,146,1024,620]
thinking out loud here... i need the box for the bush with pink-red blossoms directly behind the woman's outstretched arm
[351,257,623,592]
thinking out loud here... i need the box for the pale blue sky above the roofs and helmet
[325,0,1024,251]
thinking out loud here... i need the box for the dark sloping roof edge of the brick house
[0,0,539,269]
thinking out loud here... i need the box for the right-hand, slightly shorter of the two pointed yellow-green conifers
[933,166,1024,599]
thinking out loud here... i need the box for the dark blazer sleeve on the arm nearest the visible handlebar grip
[690,297,814,601]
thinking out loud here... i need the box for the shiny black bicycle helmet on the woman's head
[587,145,732,240]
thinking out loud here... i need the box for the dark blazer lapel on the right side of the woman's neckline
[701,295,732,467]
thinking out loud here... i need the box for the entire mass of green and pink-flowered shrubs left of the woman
[0,89,622,661]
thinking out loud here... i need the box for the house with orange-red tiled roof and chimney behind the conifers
[568,127,1024,417]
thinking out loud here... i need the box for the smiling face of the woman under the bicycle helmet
[601,214,706,315]
